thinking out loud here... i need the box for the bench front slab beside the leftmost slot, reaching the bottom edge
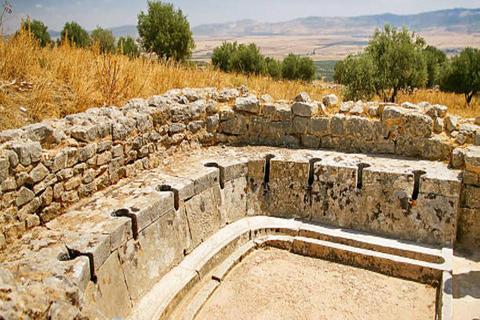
[84,253,132,319]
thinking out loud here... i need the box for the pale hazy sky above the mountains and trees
[0,0,480,34]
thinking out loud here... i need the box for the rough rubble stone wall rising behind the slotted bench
[0,87,480,248]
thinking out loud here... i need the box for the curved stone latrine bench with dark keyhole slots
[0,147,462,319]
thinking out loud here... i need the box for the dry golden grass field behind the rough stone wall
[0,31,480,130]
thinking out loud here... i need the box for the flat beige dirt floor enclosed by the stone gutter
[196,248,436,320]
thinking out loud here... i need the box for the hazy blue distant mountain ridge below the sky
[192,8,480,37]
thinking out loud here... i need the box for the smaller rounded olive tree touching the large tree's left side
[335,53,375,101]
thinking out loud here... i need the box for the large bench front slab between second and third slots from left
[118,206,190,301]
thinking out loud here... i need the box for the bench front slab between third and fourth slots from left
[185,186,224,249]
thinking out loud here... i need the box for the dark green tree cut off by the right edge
[440,48,480,105]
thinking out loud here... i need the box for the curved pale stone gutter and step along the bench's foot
[126,217,452,319]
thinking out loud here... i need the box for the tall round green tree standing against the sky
[137,1,195,61]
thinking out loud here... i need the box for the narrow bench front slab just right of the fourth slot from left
[219,176,247,224]
